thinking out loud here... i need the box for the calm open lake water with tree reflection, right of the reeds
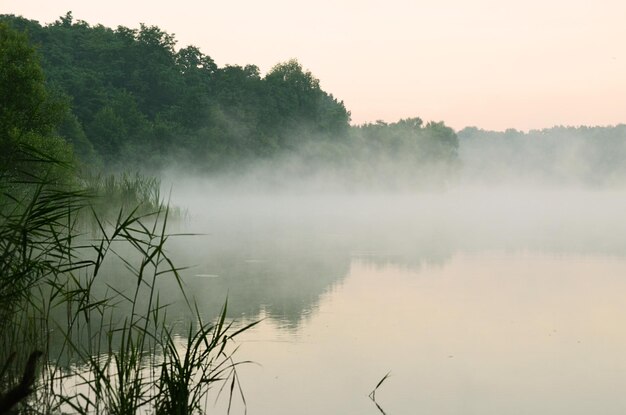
[158,189,626,415]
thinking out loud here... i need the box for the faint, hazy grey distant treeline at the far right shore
[458,124,626,186]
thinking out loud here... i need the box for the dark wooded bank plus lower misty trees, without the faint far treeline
[0,13,458,184]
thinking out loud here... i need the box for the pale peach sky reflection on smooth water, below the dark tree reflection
[213,253,626,414]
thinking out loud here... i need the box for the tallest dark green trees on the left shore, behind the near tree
[0,13,349,169]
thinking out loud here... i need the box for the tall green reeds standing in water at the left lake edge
[0,148,251,414]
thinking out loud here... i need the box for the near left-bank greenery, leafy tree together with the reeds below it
[0,22,254,414]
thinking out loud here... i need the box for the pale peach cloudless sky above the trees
[0,0,626,130]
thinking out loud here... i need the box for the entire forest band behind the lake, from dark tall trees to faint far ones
[0,12,626,189]
